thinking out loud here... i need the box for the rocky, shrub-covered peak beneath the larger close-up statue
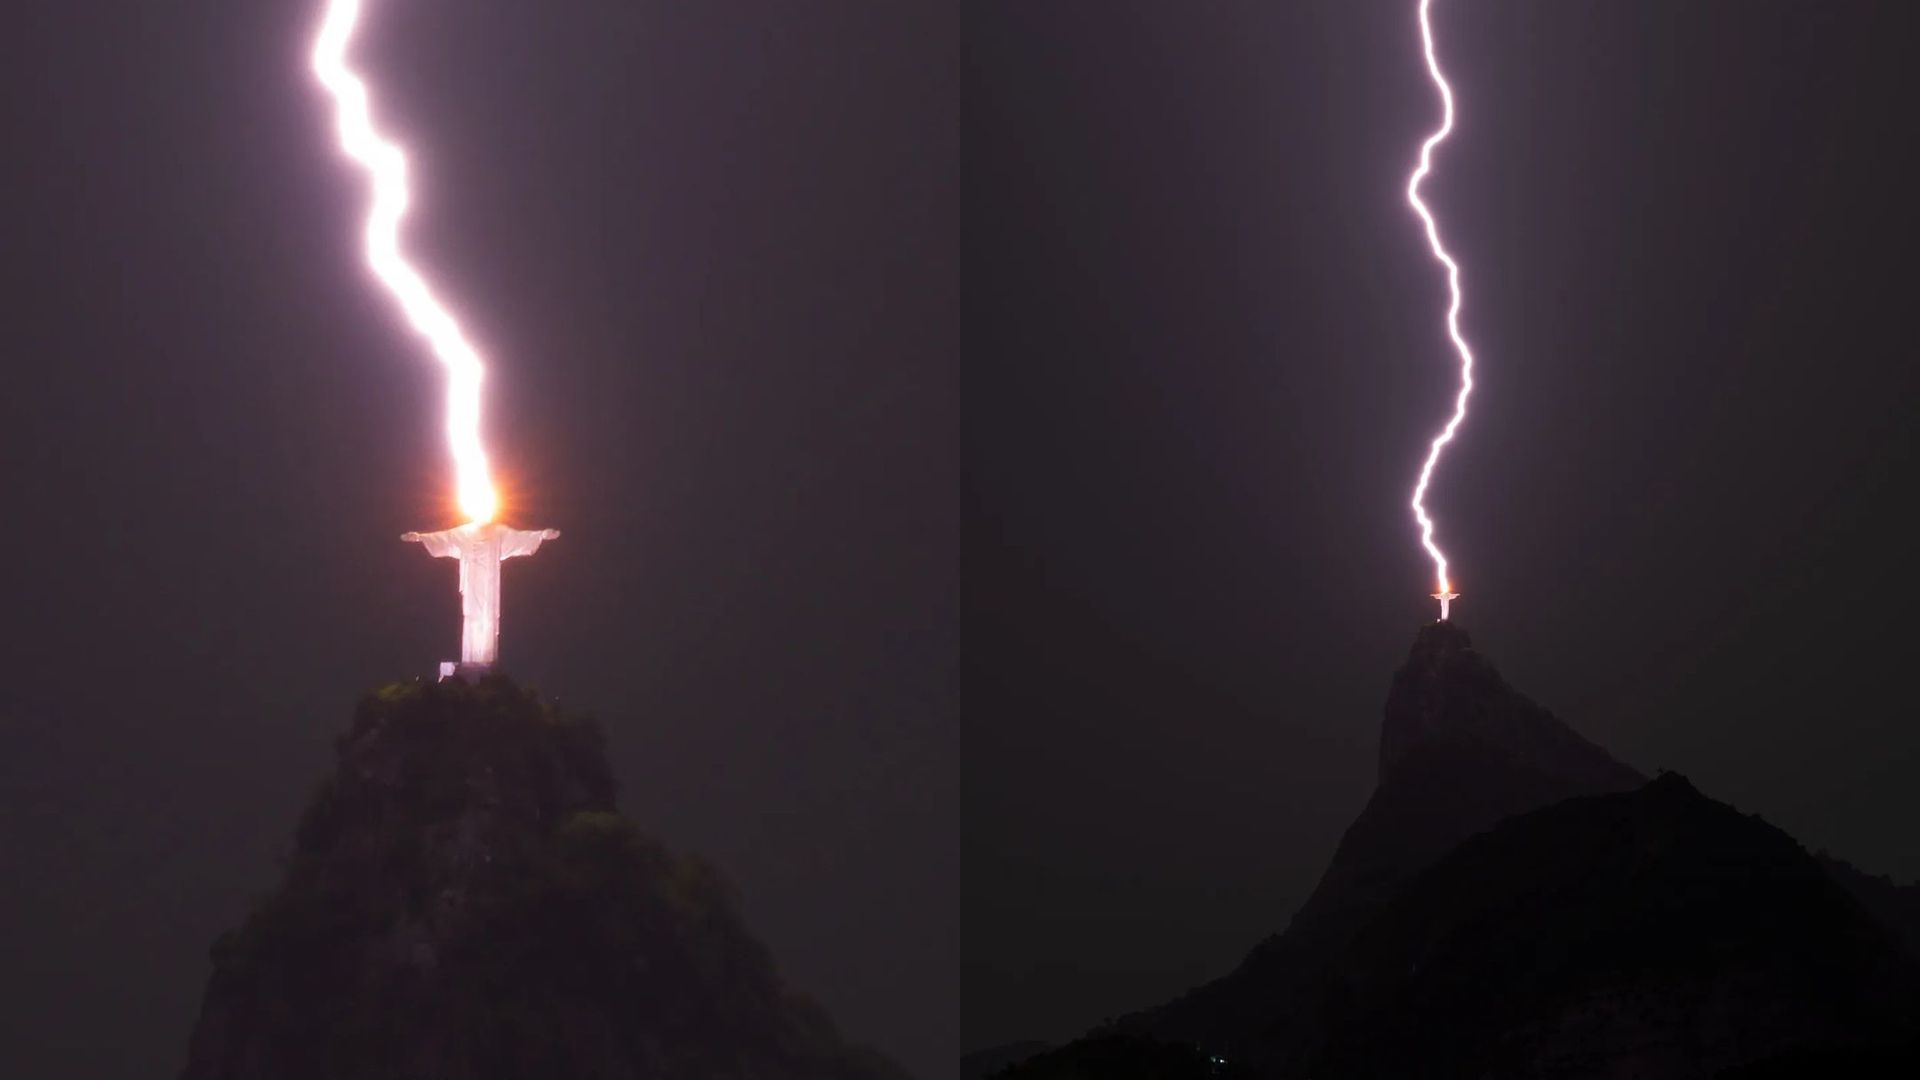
[180,676,900,1080]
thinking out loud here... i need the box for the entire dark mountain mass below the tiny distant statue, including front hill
[1000,623,1920,1080]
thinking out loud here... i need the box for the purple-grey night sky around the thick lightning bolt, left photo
[0,0,960,1080]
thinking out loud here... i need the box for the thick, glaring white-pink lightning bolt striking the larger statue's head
[313,0,499,523]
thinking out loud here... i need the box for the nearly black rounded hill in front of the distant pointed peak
[1311,773,1920,1080]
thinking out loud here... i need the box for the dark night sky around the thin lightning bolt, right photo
[962,0,1920,1047]
